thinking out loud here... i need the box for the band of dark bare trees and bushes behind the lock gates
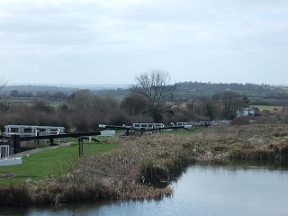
[0,70,286,132]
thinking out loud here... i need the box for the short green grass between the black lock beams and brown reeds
[0,139,116,186]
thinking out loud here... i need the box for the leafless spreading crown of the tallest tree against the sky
[132,69,175,104]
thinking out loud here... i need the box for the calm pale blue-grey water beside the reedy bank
[0,164,288,216]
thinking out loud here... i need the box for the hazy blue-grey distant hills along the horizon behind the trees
[1,82,288,106]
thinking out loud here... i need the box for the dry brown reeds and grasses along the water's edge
[0,124,288,208]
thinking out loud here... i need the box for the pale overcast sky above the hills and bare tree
[0,0,288,85]
